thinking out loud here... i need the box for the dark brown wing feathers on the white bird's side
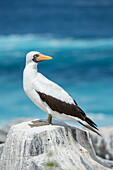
[36,91,98,130]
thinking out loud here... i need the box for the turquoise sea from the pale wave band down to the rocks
[0,34,113,126]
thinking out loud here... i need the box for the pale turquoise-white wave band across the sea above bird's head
[0,34,113,51]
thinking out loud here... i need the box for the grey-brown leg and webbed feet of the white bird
[29,115,52,127]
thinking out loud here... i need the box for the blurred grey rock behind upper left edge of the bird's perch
[0,117,33,144]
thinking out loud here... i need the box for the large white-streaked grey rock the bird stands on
[0,121,113,170]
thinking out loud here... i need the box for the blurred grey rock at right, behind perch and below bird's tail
[91,126,113,160]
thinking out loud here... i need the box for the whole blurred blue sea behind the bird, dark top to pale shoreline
[0,0,113,126]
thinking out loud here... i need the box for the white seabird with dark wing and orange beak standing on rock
[23,51,100,135]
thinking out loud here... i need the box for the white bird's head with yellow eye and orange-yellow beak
[26,51,52,64]
